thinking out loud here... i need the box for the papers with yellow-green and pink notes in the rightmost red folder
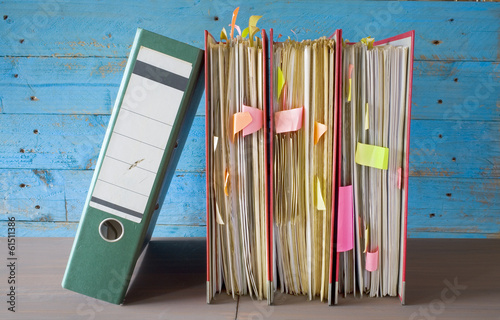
[337,33,413,304]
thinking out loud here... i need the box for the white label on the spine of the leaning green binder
[90,47,192,223]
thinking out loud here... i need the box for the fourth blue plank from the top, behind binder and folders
[0,170,500,237]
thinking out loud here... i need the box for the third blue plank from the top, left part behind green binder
[0,114,205,171]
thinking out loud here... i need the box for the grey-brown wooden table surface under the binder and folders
[0,238,500,320]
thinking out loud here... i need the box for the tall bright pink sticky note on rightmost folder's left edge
[337,185,354,252]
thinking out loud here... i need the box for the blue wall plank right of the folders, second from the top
[411,61,500,121]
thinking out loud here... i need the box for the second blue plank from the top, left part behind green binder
[0,57,205,114]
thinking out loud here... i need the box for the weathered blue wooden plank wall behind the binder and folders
[0,0,500,238]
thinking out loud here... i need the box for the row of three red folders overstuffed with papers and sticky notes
[205,20,414,304]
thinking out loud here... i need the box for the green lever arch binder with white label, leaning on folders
[62,29,203,304]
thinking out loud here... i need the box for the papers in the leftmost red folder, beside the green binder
[205,25,269,302]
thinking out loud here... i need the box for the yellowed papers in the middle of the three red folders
[271,34,338,300]
